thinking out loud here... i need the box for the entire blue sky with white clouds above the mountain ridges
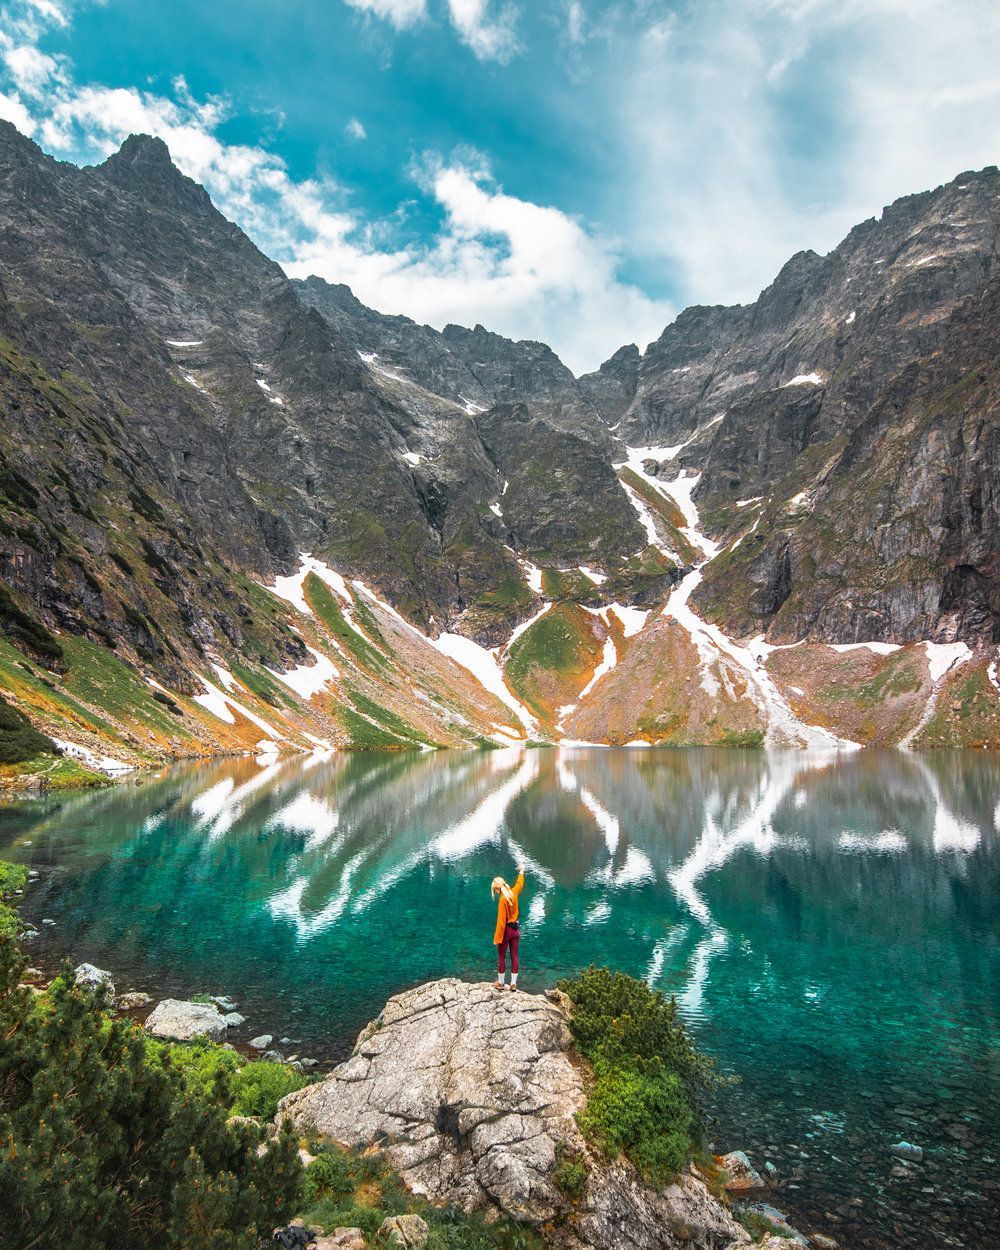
[0,0,1000,371]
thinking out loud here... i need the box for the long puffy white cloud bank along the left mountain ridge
[0,7,673,371]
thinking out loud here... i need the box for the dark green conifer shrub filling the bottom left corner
[0,936,301,1250]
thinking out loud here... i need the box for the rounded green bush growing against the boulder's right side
[559,968,720,1185]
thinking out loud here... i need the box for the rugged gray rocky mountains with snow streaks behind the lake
[0,123,1000,770]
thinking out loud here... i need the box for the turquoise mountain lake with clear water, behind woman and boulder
[0,749,1000,1248]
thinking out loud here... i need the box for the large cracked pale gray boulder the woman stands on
[278,979,749,1250]
